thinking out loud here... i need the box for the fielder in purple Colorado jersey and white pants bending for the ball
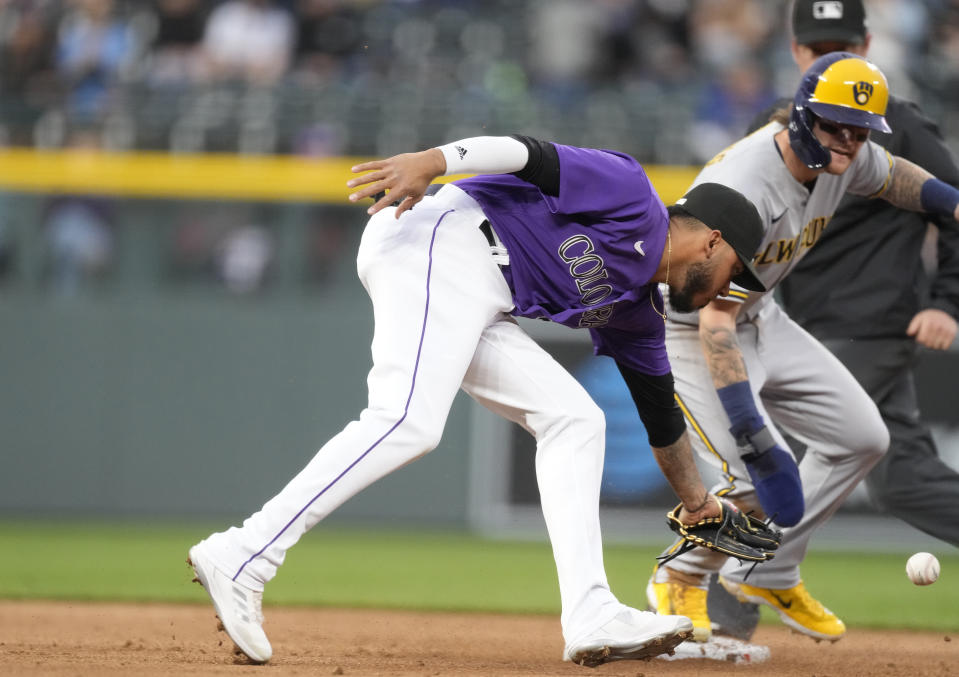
[190,137,764,666]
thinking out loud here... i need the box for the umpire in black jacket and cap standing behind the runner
[709,0,959,638]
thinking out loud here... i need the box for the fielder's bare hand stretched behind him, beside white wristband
[346,148,446,218]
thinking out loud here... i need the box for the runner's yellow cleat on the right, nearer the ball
[719,576,846,642]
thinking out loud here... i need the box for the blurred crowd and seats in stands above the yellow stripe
[0,0,959,164]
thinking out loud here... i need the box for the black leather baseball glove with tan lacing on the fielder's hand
[659,499,782,564]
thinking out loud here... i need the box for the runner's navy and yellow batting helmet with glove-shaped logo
[789,52,892,169]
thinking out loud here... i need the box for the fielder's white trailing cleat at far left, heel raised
[187,543,273,663]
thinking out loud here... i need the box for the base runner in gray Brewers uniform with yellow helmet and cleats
[648,52,959,641]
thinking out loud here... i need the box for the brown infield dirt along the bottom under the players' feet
[0,601,959,677]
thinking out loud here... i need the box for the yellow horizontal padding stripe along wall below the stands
[0,148,696,204]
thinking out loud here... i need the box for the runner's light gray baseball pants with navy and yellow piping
[666,302,889,589]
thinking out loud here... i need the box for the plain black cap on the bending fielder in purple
[676,183,766,291]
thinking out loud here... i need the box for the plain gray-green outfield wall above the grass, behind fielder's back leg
[0,294,476,523]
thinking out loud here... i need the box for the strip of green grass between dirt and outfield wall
[0,521,959,632]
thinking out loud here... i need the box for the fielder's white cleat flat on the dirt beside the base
[563,607,693,668]
